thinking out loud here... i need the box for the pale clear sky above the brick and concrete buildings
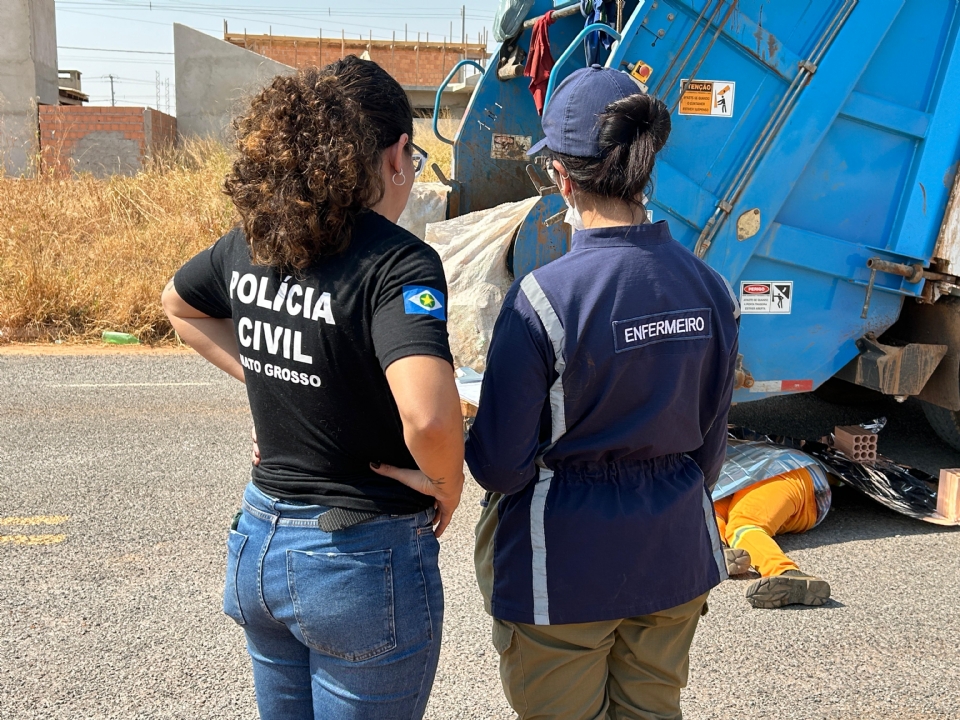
[53,0,498,114]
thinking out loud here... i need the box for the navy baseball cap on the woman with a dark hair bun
[527,65,640,157]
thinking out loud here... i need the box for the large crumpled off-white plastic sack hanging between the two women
[426,197,540,372]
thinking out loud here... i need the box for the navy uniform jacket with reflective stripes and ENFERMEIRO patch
[467,222,739,624]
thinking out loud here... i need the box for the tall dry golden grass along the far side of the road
[0,120,456,344]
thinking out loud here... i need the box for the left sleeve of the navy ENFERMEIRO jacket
[466,286,556,495]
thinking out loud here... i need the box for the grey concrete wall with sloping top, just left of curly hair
[172,24,295,140]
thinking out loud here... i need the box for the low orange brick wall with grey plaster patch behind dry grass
[40,105,177,177]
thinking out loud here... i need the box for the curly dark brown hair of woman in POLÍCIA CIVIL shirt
[224,55,413,270]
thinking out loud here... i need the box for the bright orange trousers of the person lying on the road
[713,470,817,577]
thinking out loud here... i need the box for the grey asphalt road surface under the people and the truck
[0,354,960,720]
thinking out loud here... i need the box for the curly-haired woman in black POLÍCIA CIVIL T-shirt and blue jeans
[163,56,463,720]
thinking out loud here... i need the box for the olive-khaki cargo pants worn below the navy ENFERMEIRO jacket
[493,595,707,720]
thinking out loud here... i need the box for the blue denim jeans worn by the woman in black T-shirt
[223,483,443,720]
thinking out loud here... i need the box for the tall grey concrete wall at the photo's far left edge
[0,0,59,175]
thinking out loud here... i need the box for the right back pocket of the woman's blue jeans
[287,550,397,662]
